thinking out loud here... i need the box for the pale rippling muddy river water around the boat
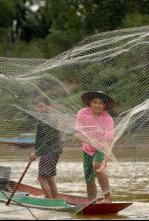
[0,149,149,220]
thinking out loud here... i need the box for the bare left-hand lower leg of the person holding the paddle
[38,176,53,199]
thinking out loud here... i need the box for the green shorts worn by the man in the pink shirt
[83,151,104,183]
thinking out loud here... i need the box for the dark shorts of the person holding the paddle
[38,154,59,177]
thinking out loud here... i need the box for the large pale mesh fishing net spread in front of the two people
[0,27,149,219]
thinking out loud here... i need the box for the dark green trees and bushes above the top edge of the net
[0,0,149,58]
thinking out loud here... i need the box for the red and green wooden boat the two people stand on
[0,181,132,215]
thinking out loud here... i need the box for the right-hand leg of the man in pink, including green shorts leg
[93,152,111,202]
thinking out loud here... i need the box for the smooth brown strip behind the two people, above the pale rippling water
[0,139,149,162]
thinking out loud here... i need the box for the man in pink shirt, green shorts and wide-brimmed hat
[76,91,116,203]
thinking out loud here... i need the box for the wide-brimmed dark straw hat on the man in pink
[81,91,116,110]
